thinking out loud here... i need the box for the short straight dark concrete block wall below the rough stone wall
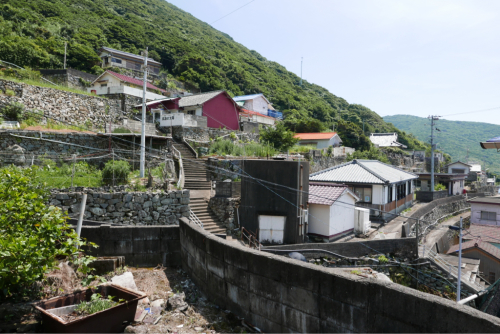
[81,225,181,267]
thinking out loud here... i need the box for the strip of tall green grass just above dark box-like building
[208,140,278,157]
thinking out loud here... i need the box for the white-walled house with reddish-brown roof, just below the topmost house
[87,70,165,102]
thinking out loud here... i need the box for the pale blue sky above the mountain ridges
[169,0,500,124]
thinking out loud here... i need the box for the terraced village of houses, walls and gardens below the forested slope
[0,1,500,333]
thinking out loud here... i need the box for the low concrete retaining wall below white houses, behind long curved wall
[266,238,418,259]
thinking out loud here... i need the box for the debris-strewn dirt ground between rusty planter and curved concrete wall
[125,268,250,333]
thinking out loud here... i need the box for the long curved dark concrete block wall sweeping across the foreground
[180,219,500,332]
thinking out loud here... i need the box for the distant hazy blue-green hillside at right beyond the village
[384,115,500,173]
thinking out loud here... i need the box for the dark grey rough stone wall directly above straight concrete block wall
[49,188,189,225]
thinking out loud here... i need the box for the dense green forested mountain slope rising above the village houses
[0,0,422,149]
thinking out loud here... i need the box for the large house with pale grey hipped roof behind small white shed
[309,160,418,218]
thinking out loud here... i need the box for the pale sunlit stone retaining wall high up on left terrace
[0,79,124,128]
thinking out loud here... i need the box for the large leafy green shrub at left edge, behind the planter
[0,166,93,299]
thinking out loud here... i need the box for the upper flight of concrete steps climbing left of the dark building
[174,143,210,190]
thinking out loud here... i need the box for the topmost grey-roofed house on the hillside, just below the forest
[98,46,161,76]
